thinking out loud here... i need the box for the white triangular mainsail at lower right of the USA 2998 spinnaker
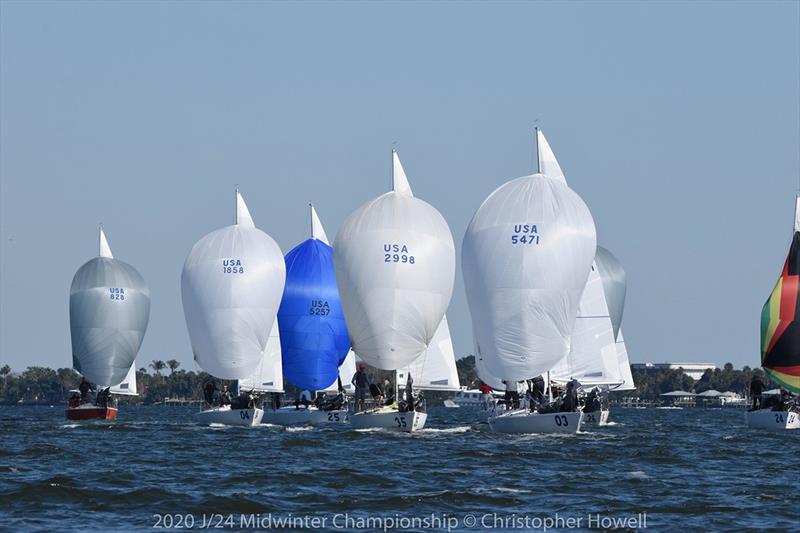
[397,316,461,391]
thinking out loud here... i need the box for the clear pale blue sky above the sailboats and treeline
[0,0,800,370]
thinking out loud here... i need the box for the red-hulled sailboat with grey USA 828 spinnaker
[66,227,150,420]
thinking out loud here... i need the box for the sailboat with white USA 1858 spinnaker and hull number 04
[181,189,286,426]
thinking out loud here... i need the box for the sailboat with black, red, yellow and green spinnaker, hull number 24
[745,196,800,430]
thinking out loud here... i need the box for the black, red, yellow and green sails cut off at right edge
[761,196,800,392]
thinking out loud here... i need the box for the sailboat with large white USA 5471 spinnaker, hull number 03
[461,128,597,433]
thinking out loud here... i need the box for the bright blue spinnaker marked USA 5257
[278,238,350,390]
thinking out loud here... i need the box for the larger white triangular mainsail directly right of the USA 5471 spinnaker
[550,264,622,386]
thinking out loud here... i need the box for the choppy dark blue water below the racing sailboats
[0,406,800,531]
